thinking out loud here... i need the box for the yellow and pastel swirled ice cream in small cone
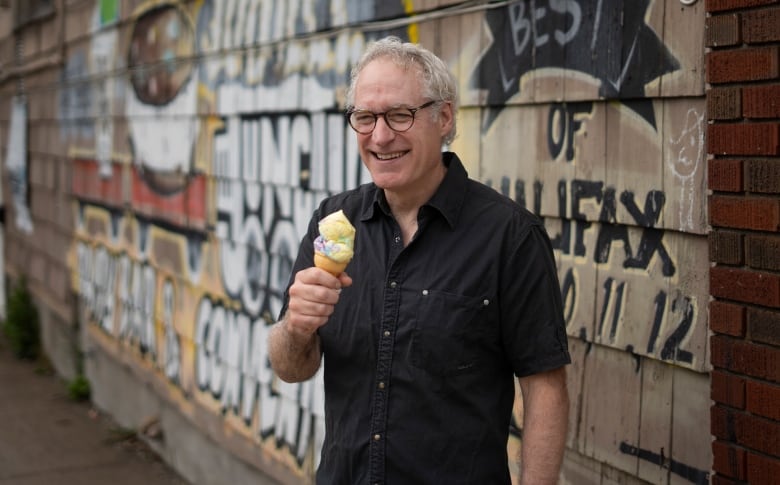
[314,210,355,276]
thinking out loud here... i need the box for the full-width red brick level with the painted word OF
[707,123,780,156]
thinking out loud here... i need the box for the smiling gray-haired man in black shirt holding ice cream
[269,38,570,485]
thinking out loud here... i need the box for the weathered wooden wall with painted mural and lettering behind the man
[64,0,710,484]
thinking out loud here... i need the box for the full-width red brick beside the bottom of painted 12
[710,335,780,382]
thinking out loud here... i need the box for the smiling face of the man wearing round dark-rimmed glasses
[355,58,452,195]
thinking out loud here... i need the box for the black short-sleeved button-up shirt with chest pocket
[282,153,570,485]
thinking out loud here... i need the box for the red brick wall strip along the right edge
[705,0,780,485]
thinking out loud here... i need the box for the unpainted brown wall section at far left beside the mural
[0,2,80,378]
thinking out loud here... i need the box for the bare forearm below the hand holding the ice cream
[268,319,322,382]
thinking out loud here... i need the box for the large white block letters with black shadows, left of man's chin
[214,113,366,318]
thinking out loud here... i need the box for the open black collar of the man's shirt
[361,152,468,228]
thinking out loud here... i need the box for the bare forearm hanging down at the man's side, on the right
[520,371,569,485]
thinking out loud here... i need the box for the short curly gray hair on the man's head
[347,36,458,144]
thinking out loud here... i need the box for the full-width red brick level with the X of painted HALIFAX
[709,195,780,232]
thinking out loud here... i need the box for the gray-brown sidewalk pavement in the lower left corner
[0,336,187,485]
